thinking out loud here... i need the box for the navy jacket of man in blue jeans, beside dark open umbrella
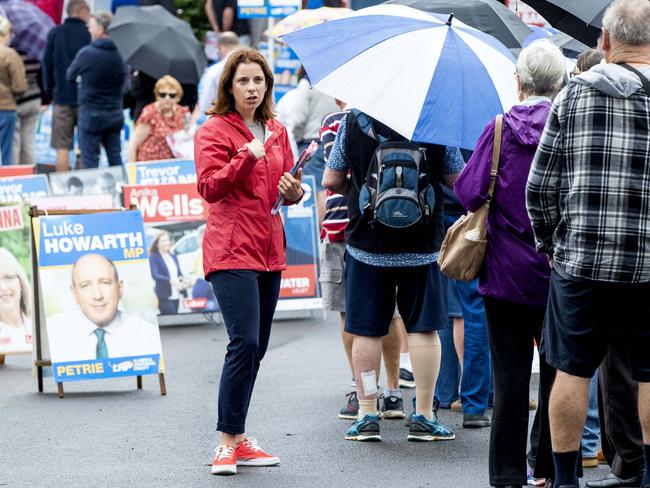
[66,37,127,110]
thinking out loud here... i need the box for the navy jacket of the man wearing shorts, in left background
[43,17,90,107]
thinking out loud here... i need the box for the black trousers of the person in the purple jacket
[483,296,554,486]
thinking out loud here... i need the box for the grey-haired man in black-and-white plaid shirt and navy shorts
[527,0,650,488]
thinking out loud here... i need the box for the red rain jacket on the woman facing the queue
[194,112,294,277]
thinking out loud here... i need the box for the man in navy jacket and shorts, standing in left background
[43,0,90,171]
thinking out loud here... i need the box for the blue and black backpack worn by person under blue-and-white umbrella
[352,110,435,229]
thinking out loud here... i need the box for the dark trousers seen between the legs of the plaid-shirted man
[598,330,645,479]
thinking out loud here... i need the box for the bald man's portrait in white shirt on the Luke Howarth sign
[46,253,161,363]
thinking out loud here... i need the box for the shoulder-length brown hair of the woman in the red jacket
[205,48,275,122]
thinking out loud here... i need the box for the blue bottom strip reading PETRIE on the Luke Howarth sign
[52,354,160,383]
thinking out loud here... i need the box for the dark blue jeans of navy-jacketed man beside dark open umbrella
[78,107,124,168]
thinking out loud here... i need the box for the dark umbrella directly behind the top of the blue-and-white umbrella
[384,0,531,49]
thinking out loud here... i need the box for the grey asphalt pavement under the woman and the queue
[0,315,607,488]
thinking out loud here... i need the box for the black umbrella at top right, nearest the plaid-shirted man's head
[512,0,612,47]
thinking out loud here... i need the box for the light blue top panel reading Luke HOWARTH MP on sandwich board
[38,210,148,267]
